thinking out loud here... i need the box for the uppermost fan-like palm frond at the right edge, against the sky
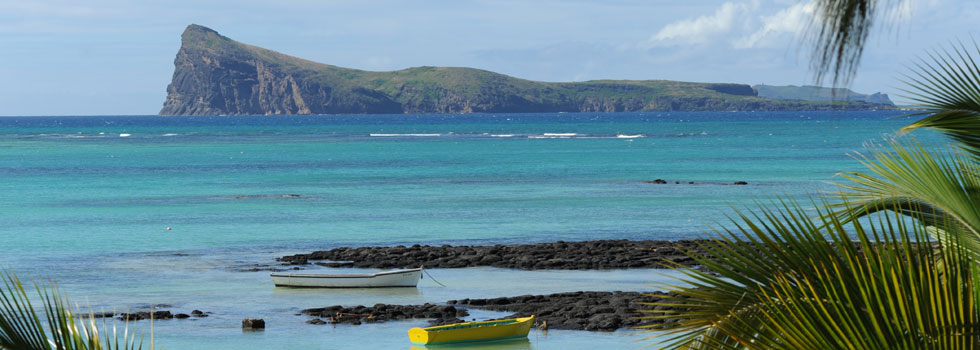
[902,42,980,158]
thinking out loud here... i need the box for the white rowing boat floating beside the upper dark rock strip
[269,267,422,288]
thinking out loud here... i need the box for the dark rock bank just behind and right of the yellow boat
[448,292,680,331]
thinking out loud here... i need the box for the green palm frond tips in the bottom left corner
[0,273,146,350]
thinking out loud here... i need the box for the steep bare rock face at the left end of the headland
[160,25,402,115]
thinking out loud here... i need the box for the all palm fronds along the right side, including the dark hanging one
[647,0,980,349]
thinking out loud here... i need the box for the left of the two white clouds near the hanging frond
[650,1,758,45]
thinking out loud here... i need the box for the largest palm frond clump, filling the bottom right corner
[643,203,980,349]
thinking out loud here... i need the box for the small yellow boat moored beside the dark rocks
[408,315,534,345]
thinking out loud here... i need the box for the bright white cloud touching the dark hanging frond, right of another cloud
[733,1,816,49]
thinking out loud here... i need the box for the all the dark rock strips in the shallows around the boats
[74,239,707,332]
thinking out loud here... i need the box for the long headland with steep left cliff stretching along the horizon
[160,24,881,115]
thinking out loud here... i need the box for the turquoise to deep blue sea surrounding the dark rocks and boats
[0,111,936,349]
